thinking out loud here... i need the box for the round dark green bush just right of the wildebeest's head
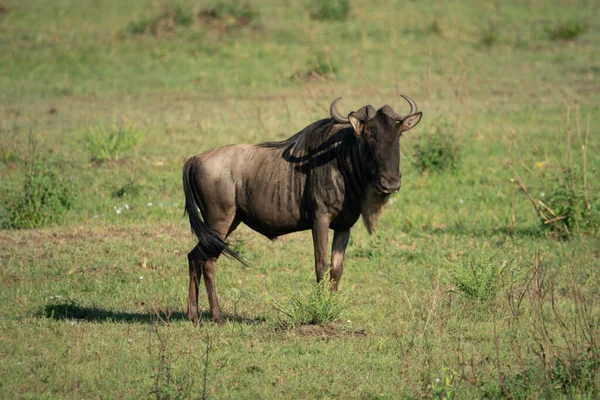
[413,115,460,172]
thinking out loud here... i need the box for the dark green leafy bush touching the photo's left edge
[1,162,74,229]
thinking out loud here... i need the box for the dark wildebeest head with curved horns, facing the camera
[330,94,422,195]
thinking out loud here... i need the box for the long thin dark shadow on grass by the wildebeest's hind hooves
[38,303,266,325]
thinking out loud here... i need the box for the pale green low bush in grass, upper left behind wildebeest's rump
[83,124,145,163]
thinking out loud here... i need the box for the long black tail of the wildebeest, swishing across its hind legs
[183,161,246,265]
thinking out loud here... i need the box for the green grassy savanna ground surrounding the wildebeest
[0,0,600,399]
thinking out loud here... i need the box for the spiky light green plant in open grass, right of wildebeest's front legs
[447,246,507,301]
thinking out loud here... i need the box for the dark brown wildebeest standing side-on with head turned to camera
[183,95,422,323]
